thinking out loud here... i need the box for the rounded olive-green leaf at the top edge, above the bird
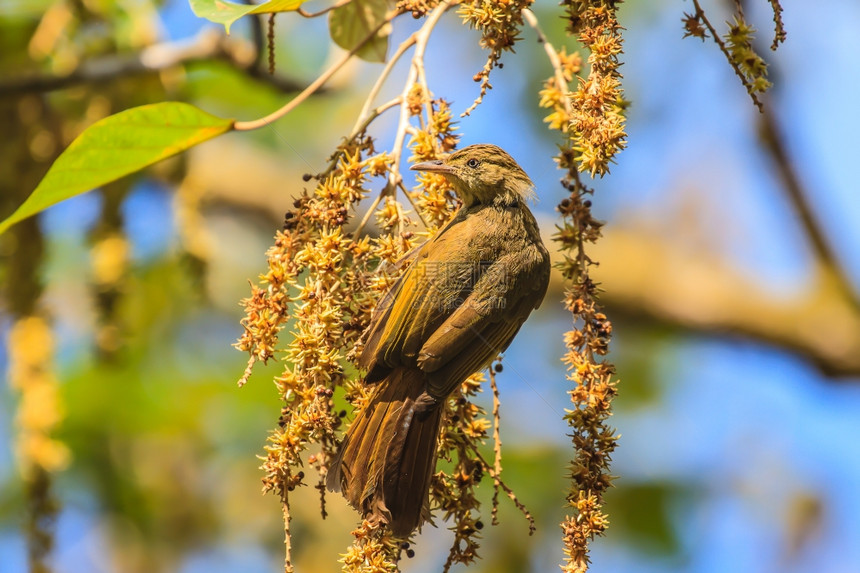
[328,0,391,62]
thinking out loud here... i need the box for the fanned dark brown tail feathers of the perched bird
[327,368,442,537]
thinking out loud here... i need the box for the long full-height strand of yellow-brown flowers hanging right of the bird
[540,0,626,573]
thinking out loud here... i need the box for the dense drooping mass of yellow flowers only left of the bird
[236,139,411,560]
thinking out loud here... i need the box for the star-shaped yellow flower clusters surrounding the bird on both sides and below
[236,84,504,572]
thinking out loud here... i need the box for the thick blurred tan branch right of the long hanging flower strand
[593,230,860,377]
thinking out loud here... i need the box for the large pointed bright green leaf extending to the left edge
[0,102,233,234]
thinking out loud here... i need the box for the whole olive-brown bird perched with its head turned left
[327,145,550,537]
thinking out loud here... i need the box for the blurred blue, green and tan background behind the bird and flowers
[0,0,860,573]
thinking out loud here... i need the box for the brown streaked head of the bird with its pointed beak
[412,144,534,207]
